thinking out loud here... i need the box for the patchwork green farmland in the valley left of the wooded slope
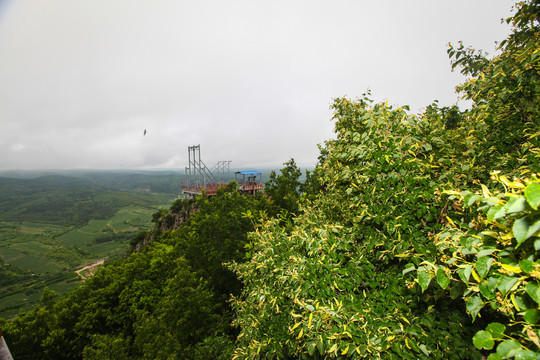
[0,172,177,318]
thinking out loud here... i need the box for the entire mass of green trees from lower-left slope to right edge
[2,1,540,360]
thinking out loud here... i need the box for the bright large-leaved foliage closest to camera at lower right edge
[412,172,540,360]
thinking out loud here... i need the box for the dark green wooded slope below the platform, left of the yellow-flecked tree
[3,189,269,359]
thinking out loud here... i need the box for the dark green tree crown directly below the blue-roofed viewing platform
[164,186,270,302]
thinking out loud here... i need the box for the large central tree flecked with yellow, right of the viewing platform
[233,97,480,359]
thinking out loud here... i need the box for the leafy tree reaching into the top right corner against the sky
[448,0,540,174]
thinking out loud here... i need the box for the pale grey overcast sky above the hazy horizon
[0,0,513,169]
